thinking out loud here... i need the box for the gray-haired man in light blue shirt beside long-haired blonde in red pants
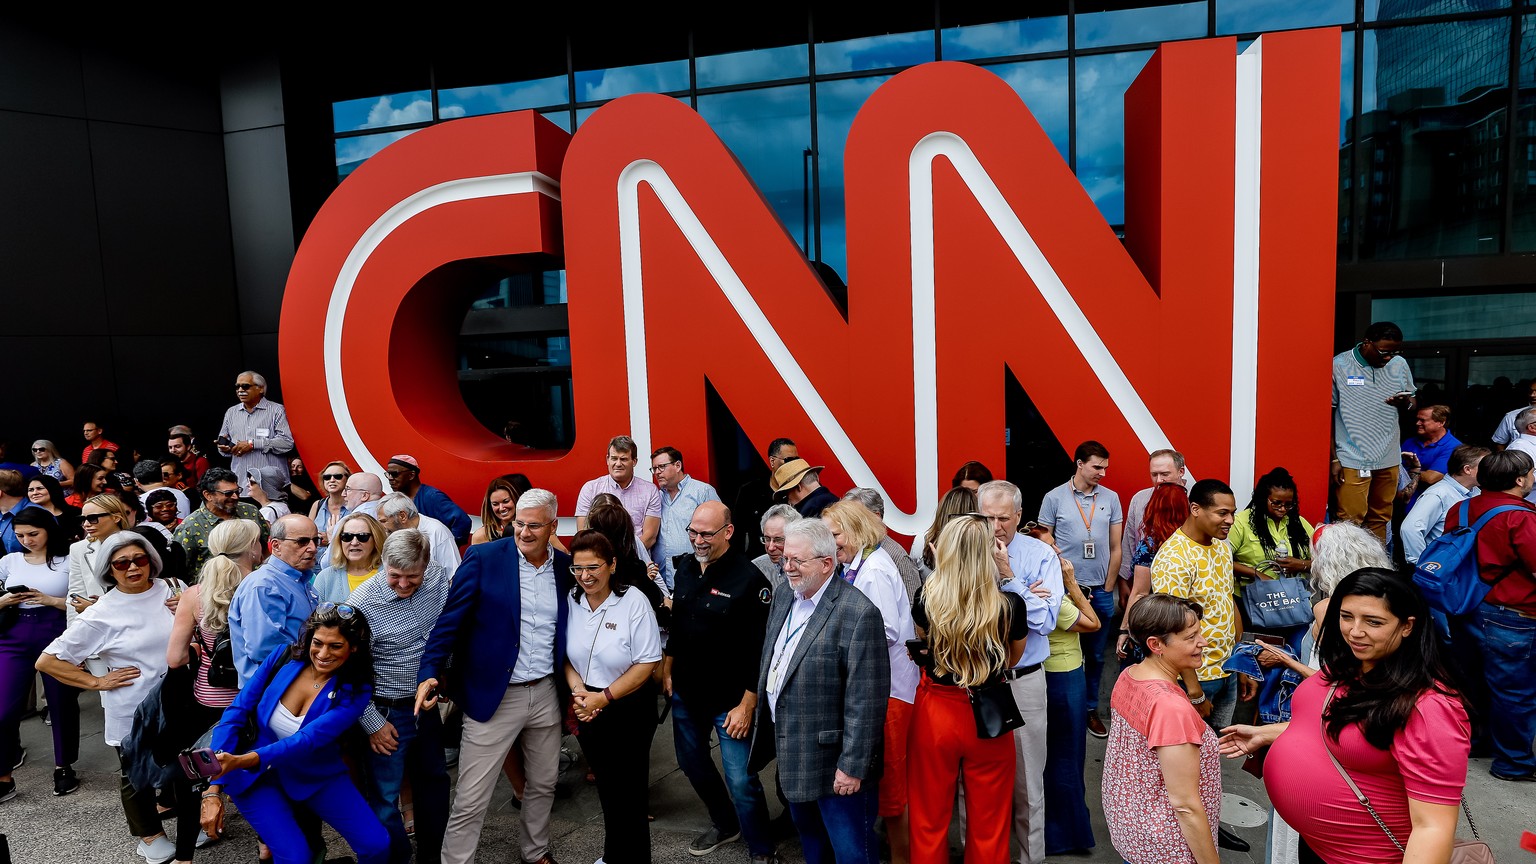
[975,480,1066,864]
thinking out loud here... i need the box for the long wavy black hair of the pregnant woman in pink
[1318,567,1471,750]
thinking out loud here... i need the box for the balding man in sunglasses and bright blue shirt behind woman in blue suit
[229,513,319,687]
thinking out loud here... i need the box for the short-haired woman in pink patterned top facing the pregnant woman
[1103,593,1221,864]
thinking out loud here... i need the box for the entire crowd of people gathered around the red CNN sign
[0,324,1536,864]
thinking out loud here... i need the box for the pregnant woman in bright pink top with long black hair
[1221,567,1471,864]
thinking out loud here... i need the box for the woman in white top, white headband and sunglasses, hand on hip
[37,528,185,864]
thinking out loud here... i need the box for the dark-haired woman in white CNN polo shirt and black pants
[565,529,662,864]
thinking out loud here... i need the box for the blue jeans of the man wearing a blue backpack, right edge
[1467,603,1536,776]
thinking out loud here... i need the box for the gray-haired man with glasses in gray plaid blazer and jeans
[748,520,891,864]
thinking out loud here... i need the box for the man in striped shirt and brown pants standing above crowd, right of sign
[1329,321,1418,543]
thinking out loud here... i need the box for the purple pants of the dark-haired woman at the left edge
[0,607,80,765]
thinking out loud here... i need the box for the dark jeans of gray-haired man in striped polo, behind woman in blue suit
[366,707,449,864]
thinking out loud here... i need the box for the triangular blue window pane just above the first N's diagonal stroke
[699,85,817,257]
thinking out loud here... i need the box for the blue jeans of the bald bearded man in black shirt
[673,693,773,855]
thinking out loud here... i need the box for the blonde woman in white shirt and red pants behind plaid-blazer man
[822,501,922,864]
